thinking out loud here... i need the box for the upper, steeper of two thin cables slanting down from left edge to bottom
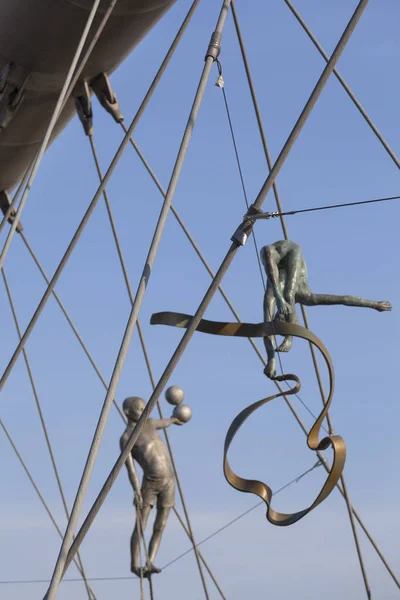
[1,267,96,600]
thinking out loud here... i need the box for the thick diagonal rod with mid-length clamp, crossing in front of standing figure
[54,0,368,580]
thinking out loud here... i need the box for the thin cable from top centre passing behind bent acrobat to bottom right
[232,3,371,598]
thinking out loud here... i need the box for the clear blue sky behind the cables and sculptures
[0,0,400,600]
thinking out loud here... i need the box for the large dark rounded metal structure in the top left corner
[0,0,175,191]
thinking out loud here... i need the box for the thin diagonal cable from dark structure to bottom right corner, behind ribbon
[121,99,400,588]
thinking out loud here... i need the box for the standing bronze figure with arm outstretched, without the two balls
[120,397,183,577]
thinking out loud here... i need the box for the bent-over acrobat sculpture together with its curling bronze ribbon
[150,240,392,526]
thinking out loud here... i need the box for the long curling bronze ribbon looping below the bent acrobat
[150,312,346,526]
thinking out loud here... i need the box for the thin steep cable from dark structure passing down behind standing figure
[88,134,209,600]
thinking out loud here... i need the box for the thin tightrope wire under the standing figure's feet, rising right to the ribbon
[0,460,322,585]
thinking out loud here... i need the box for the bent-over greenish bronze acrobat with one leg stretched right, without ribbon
[260,240,392,378]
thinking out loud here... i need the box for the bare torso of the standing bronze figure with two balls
[121,419,173,479]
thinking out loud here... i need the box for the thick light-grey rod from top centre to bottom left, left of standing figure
[46,0,219,600]
